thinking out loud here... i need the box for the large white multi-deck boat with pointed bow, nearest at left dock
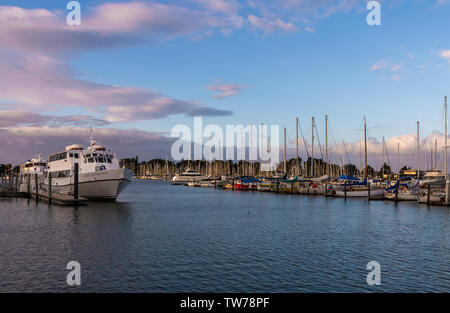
[45,131,133,200]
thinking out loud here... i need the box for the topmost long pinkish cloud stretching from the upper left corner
[0,1,242,54]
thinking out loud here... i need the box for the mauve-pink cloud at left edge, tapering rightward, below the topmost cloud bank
[0,34,231,122]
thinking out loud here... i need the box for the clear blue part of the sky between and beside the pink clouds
[0,0,450,166]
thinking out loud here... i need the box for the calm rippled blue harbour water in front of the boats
[0,181,450,292]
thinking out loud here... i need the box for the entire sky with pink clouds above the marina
[0,0,450,171]
